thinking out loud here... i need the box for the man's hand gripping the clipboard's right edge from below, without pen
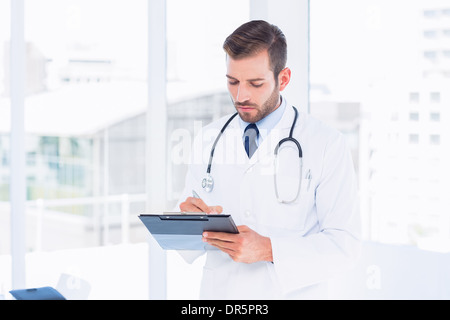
[203,226,273,263]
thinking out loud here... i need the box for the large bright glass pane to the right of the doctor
[310,0,450,250]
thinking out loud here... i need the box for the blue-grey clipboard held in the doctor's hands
[139,212,239,250]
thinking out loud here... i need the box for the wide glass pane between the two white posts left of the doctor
[21,0,148,298]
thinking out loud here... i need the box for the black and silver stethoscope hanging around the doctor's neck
[202,106,303,204]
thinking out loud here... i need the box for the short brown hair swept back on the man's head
[223,20,287,80]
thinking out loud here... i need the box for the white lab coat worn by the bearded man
[180,105,360,299]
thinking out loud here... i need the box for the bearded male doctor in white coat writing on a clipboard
[179,21,360,299]
